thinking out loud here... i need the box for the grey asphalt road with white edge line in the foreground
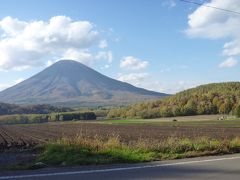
[0,154,240,180]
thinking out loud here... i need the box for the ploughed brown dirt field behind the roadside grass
[0,123,240,150]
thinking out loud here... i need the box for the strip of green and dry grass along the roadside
[37,136,240,166]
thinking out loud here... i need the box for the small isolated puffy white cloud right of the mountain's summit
[120,56,149,70]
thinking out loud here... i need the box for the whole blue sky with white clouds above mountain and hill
[0,0,240,93]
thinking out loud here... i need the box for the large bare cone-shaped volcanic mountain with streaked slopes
[0,60,167,107]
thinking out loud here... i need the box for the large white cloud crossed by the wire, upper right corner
[186,0,240,66]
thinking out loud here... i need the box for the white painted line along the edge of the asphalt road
[0,156,240,179]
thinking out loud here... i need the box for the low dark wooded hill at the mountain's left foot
[0,102,71,115]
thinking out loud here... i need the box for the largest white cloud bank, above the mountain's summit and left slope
[0,16,107,70]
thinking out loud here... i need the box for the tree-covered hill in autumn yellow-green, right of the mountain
[108,82,240,118]
